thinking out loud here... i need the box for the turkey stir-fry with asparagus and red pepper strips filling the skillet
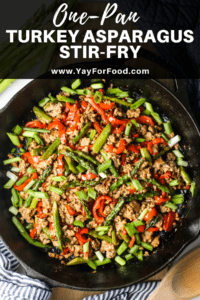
[4,79,195,270]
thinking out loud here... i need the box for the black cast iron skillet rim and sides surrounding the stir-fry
[0,74,200,291]
